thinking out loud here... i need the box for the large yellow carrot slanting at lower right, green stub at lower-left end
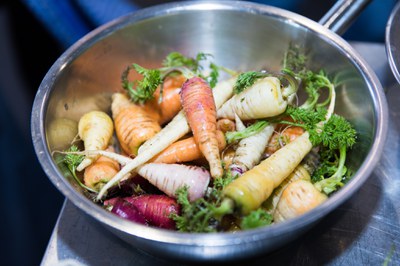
[223,132,312,214]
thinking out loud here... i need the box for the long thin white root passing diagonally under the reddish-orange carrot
[97,77,236,200]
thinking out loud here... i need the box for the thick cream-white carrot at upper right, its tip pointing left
[217,77,287,120]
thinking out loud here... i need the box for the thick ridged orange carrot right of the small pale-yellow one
[111,93,161,156]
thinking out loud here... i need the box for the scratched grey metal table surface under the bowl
[42,43,400,265]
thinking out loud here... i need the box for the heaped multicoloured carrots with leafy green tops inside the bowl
[54,46,356,232]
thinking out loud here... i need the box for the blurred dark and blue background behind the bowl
[0,0,397,265]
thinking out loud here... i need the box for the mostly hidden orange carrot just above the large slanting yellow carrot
[264,126,304,157]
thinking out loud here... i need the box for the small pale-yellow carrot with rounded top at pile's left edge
[76,111,114,171]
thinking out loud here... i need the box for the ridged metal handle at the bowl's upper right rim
[319,0,371,35]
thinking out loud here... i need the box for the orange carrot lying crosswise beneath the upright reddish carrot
[150,130,226,163]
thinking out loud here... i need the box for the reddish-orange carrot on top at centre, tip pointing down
[181,77,223,178]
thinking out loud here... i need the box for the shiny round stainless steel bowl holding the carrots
[32,1,387,260]
